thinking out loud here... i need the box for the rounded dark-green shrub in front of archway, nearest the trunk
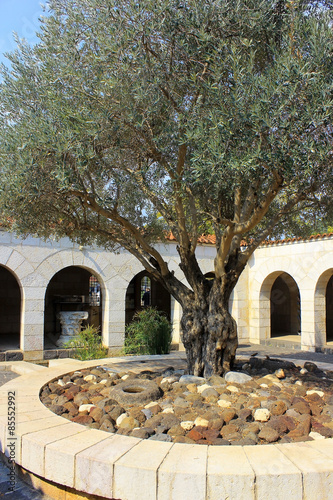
[124,307,172,354]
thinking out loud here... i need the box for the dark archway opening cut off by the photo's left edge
[0,266,21,351]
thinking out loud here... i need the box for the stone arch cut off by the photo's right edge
[314,268,333,347]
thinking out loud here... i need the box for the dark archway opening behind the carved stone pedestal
[44,266,102,349]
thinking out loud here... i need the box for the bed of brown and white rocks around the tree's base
[41,352,333,445]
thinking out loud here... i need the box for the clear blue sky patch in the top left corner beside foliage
[0,0,46,66]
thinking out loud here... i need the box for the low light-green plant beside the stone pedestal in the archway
[65,325,108,361]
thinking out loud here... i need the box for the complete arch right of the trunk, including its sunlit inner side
[259,271,301,340]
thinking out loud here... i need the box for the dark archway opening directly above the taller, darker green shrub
[125,271,171,325]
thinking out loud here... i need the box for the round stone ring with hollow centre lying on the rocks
[110,379,162,405]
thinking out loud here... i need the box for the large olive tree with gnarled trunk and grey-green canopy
[0,0,333,376]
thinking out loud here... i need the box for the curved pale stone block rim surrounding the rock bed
[0,356,333,500]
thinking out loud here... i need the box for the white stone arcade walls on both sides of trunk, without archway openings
[0,231,333,357]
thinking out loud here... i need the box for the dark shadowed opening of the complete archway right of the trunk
[270,273,301,337]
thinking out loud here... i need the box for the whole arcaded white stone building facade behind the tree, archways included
[0,231,333,360]
